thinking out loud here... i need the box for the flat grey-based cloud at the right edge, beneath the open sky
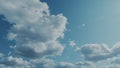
[79,43,120,61]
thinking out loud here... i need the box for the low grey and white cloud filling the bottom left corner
[0,56,29,68]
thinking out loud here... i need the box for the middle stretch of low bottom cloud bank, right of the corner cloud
[31,58,95,68]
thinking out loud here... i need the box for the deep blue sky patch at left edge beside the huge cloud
[0,15,14,54]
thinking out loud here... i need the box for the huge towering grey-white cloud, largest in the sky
[0,0,67,58]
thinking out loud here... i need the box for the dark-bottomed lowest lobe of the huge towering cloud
[15,42,64,58]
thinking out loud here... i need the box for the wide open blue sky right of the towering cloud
[43,0,120,44]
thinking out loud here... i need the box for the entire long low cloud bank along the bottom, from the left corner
[0,53,95,68]
